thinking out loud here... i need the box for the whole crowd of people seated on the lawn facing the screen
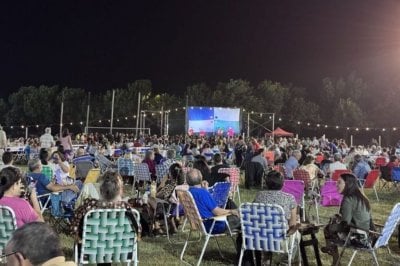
[0,125,398,262]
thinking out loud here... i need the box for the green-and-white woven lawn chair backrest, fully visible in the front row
[75,209,140,265]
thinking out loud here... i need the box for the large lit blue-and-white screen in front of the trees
[187,106,240,136]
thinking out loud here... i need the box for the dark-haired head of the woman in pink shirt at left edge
[0,166,23,199]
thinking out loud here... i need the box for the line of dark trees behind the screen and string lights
[0,73,400,138]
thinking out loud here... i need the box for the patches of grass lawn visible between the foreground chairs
[43,171,400,265]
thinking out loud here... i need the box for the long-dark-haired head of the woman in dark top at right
[337,173,371,210]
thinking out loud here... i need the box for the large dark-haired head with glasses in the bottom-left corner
[5,222,64,266]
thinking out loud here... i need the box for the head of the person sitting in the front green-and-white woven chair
[100,171,123,202]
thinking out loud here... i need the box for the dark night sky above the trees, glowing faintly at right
[0,0,400,96]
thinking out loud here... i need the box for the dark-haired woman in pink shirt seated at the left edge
[0,167,43,227]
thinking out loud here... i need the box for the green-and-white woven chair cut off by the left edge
[0,206,17,254]
